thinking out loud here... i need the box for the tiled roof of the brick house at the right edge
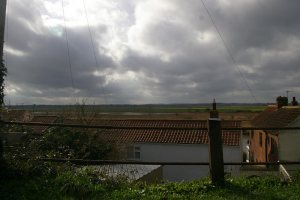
[252,107,300,127]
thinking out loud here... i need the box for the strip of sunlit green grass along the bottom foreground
[0,167,300,200]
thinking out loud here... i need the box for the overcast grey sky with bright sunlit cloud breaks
[4,0,300,104]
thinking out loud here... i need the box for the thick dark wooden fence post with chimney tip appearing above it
[208,100,224,186]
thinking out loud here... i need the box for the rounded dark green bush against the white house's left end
[38,128,113,159]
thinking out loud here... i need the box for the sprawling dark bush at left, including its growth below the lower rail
[0,128,113,179]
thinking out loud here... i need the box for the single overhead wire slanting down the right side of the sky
[201,0,257,103]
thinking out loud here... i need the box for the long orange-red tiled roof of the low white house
[95,120,241,146]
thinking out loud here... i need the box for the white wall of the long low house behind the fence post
[135,143,242,181]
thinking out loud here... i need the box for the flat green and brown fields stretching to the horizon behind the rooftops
[7,104,266,120]
